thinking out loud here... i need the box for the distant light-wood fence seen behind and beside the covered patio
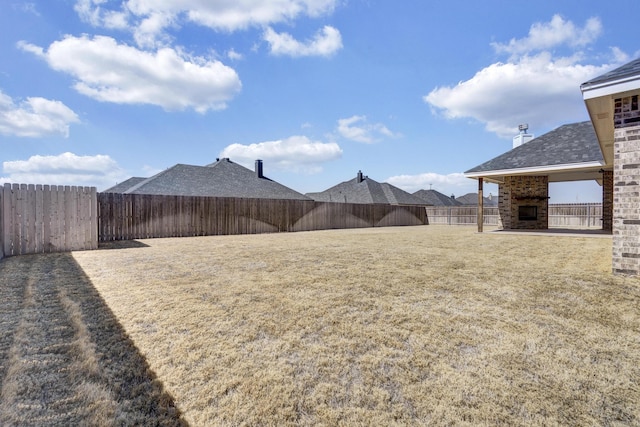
[426,203,602,228]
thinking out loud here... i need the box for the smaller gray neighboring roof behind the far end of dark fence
[306,172,426,205]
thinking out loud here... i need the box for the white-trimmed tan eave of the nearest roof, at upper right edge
[580,75,640,165]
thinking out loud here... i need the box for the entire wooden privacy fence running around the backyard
[0,184,602,258]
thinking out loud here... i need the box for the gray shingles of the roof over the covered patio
[465,122,603,173]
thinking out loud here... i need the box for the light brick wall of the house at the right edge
[612,123,640,275]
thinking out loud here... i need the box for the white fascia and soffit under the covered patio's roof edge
[464,162,611,185]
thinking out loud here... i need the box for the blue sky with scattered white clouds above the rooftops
[0,0,640,203]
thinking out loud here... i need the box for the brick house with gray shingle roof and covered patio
[465,58,640,275]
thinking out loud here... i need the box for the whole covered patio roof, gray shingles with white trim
[465,122,604,182]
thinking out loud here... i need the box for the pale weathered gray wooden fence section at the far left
[0,184,98,258]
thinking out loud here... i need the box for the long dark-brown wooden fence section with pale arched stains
[98,193,428,241]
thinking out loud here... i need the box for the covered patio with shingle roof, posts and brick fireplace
[465,122,613,233]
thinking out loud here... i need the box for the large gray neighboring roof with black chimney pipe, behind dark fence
[108,158,309,200]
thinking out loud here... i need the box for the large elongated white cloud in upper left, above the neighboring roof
[19,36,241,113]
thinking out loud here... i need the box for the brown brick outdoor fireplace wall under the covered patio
[498,176,549,230]
